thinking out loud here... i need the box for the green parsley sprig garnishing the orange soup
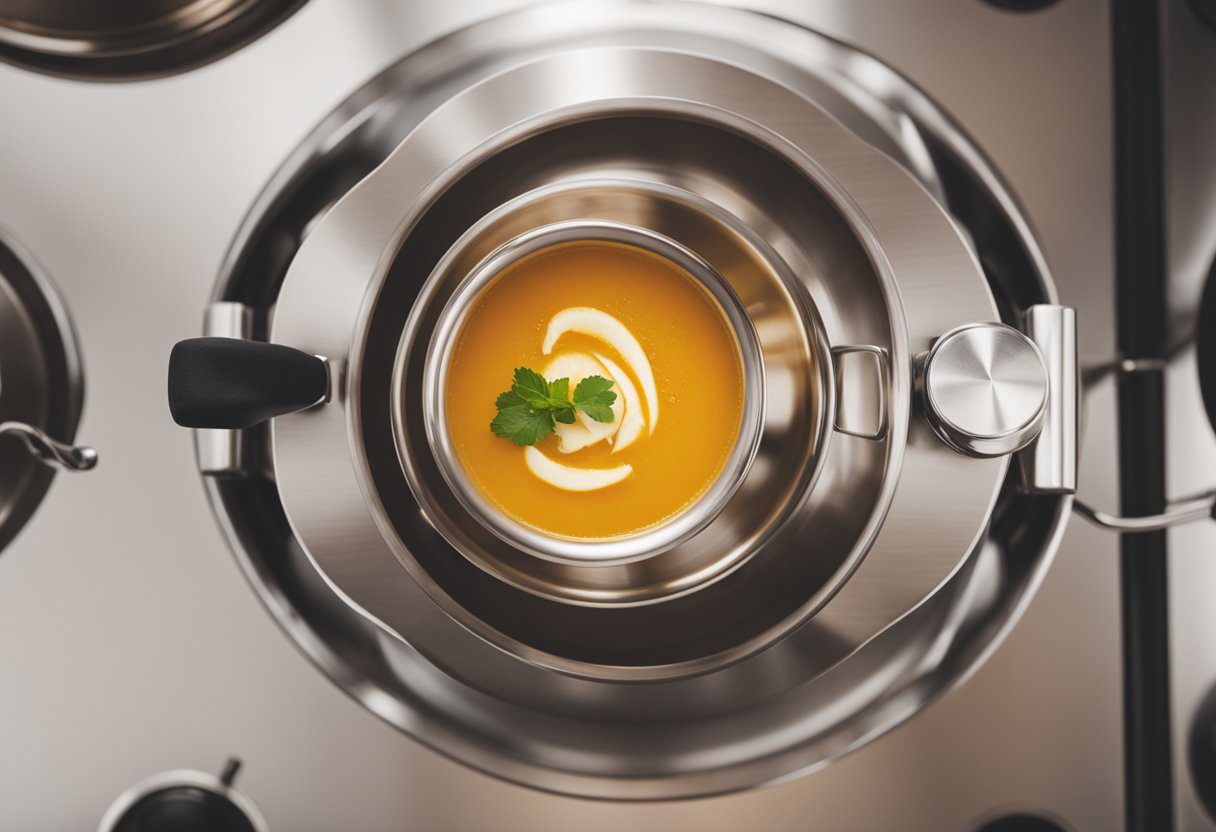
[490,367,617,445]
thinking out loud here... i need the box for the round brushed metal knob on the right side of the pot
[923,324,1047,456]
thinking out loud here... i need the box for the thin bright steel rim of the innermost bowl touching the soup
[413,220,765,564]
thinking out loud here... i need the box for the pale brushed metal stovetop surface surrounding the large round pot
[0,0,1123,832]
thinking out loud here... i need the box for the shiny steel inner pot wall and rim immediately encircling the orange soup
[403,194,841,605]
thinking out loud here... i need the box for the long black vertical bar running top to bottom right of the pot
[1111,0,1173,832]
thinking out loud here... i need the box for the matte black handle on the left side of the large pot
[169,338,330,428]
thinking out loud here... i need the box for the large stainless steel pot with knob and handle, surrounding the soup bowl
[166,4,1076,799]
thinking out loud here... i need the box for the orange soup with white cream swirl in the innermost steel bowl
[443,241,743,540]
